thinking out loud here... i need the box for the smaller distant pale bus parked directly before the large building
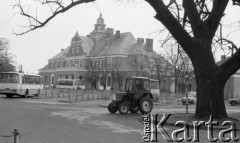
[56,79,85,89]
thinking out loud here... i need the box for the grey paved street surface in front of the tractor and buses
[0,95,240,143]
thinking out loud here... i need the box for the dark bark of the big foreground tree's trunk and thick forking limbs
[146,0,240,118]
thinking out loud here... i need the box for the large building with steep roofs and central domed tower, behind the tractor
[39,14,172,89]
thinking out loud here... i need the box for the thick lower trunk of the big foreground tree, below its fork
[195,65,228,118]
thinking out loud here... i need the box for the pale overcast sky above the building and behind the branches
[0,0,240,73]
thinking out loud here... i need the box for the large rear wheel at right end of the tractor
[139,97,153,114]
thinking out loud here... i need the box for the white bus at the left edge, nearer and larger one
[0,72,43,98]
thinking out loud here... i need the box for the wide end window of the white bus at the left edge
[0,73,19,83]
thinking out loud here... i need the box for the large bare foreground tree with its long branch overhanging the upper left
[12,0,240,118]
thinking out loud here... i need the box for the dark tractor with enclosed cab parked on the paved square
[108,77,153,114]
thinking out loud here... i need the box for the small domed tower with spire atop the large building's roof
[90,13,106,40]
